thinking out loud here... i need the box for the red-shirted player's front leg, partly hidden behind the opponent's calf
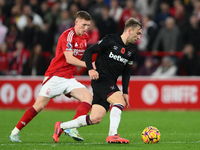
[64,79,92,141]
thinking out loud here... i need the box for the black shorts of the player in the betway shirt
[91,77,120,111]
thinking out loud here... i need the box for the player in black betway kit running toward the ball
[53,18,142,143]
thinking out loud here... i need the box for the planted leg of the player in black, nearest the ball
[106,91,129,143]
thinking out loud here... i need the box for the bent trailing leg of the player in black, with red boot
[53,105,106,143]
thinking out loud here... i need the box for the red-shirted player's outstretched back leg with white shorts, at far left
[9,76,66,142]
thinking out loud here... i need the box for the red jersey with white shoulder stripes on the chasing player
[45,27,89,78]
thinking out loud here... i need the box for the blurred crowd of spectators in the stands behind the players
[0,0,200,76]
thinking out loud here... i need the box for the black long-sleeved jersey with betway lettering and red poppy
[84,34,136,93]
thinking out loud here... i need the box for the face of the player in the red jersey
[75,18,91,36]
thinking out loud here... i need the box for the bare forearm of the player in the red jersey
[64,51,86,67]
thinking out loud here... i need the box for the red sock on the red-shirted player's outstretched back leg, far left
[16,107,38,130]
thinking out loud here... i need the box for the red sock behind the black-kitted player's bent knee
[73,102,91,119]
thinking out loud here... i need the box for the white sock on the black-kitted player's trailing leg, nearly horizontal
[60,115,92,129]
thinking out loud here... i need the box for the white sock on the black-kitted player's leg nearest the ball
[108,104,124,136]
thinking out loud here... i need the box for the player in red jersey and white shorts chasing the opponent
[9,11,92,142]
